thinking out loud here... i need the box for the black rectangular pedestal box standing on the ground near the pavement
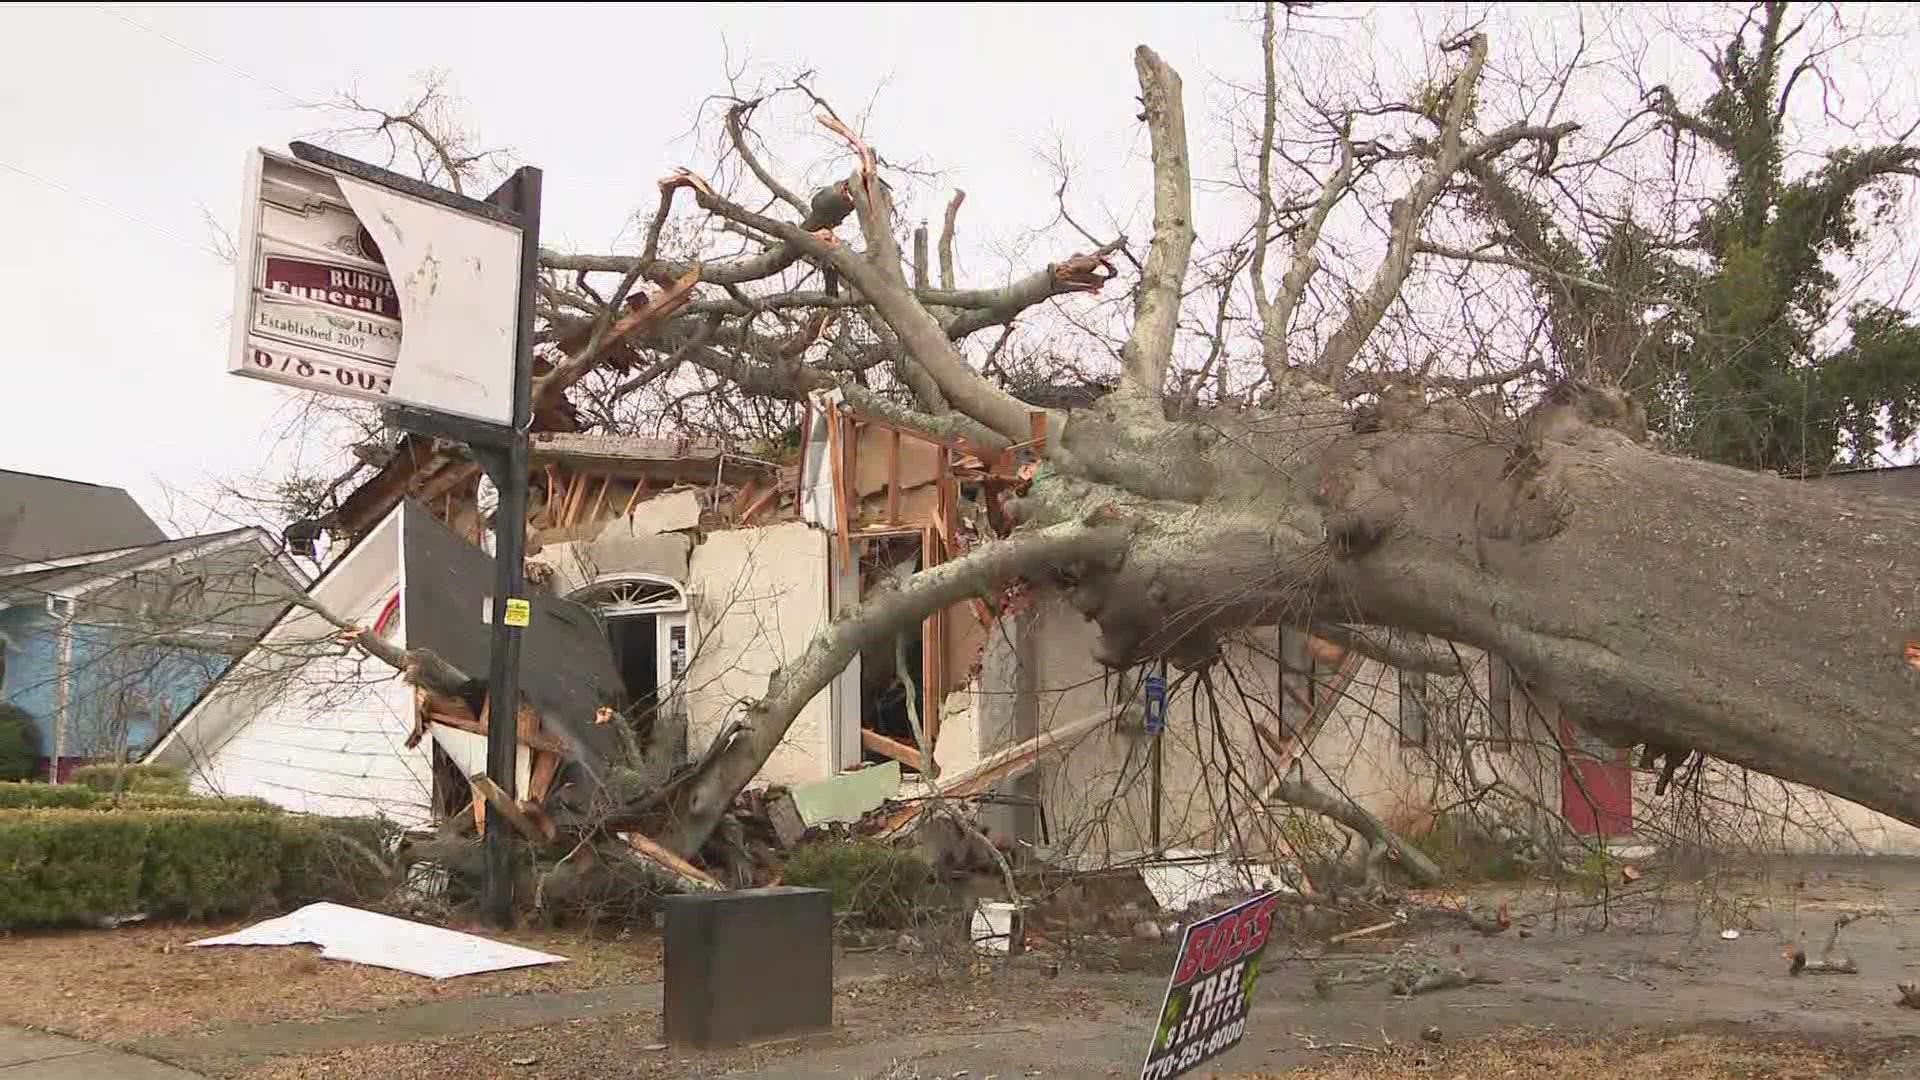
[662,886,833,1049]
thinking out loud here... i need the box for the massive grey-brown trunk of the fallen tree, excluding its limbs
[1073,386,1920,824]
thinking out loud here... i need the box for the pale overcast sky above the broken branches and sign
[0,4,1912,523]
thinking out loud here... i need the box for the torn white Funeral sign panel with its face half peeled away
[227,150,522,425]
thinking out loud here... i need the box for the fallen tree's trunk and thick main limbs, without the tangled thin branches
[602,35,1920,853]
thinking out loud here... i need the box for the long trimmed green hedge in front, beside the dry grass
[0,809,394,928]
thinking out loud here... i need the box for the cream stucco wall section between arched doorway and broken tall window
[687,523,835,784]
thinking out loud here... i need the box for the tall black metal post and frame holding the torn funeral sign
[292,142,541,926]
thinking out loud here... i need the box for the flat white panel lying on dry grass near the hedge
[190,903,566,978]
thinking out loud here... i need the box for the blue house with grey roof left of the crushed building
[0,469,305,778]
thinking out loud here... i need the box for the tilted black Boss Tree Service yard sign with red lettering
[1140,892,1281,1080]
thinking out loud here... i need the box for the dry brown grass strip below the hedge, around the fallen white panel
[0,910,660,1043]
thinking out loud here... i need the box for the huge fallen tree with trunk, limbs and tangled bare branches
[291,6,1920,861]
